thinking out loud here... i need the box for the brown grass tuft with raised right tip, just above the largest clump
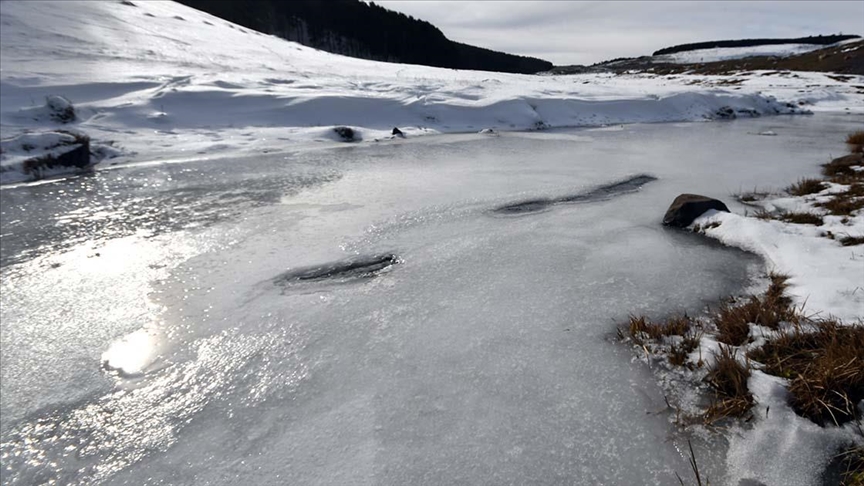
[714,273,800,346]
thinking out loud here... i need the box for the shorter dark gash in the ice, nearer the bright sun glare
[274,253,402,285]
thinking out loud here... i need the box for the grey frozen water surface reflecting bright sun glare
[0,114,864,485]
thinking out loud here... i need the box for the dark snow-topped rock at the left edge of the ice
[0,131,90,179]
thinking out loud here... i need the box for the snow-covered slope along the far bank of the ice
[0,1,864,181]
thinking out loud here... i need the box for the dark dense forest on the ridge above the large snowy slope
[178,0,552,74]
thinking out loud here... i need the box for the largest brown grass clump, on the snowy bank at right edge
[749,320,864,425]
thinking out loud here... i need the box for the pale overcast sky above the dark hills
[375,0,864,65]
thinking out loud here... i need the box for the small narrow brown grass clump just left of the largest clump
[704,345,754,423]
